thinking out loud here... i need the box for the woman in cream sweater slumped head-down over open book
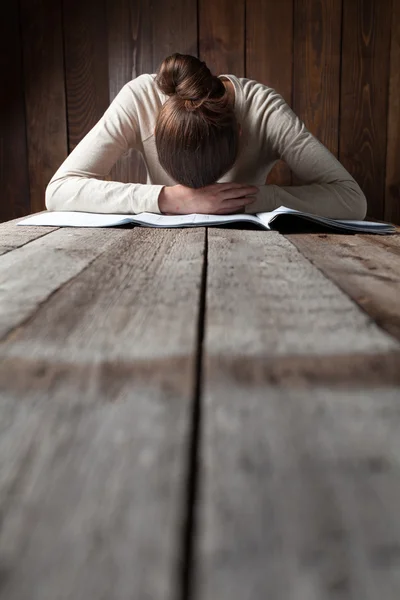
[46,54,366,219]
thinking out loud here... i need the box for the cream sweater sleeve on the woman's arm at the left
[45,80,163,214]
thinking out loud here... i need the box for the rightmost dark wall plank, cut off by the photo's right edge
[385,0,400,224]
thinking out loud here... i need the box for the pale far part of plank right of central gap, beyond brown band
[207,229,394,356]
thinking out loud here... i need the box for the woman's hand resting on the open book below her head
[158,183,258,215]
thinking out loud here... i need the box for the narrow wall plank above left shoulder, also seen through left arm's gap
[107,0,147,183]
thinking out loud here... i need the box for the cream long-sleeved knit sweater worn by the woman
[46,75,366,219]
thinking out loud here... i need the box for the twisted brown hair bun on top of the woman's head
[156,53,225,107]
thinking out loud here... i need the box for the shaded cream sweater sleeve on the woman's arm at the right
[244,84,367,219]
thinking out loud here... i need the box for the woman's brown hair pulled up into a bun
[155,53,239,188]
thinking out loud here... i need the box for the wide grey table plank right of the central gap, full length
[196,230,400,600]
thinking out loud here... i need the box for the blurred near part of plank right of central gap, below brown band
[197,376,400,600]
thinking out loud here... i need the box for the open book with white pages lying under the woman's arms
[18,206,396,233]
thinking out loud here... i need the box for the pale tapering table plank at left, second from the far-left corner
[0,227,129,340]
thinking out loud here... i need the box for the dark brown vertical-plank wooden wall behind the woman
[0,0,400,223]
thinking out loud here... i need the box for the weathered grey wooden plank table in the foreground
[0,217,400,600]
